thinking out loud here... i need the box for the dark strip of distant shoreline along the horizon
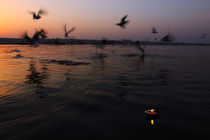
[0,38,210,46]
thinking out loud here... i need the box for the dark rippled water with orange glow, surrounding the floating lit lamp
[0,45,210,140]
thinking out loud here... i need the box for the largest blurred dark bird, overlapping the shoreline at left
[23,30,43,46]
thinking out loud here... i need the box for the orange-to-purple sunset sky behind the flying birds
[0,0,210,42]
